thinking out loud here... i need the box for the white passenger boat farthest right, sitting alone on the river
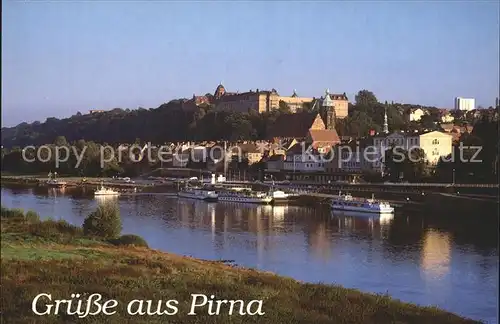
[331,193,394,214]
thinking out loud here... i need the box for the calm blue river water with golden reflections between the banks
[1,186,498,323]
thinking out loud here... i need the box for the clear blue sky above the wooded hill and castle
[2,0,500,127]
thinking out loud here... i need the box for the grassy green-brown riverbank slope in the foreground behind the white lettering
[0,207,482,324]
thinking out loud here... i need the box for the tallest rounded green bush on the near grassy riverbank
[83,202,122,239]
